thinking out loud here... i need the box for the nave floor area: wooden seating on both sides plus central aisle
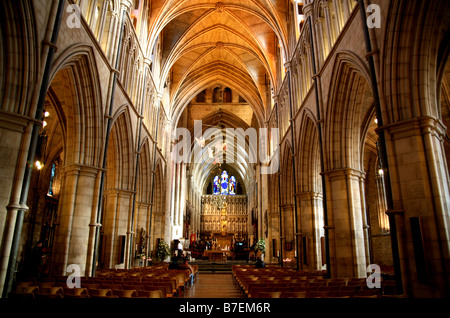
[9,263,402,299]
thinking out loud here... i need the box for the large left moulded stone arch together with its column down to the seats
[38,44,103,275]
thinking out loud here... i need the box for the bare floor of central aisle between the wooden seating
[184,273,243,298]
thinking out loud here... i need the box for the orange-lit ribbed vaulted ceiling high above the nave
[149,0,289,122]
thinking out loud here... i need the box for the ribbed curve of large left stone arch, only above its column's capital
[49,44,104,167]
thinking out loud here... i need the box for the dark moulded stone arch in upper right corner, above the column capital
[379,0,448,124]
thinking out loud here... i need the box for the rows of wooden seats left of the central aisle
[9,264,198,298]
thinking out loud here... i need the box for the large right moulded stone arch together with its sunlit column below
[324,52,373,277]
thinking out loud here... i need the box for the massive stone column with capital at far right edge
[383,117,450,297]
